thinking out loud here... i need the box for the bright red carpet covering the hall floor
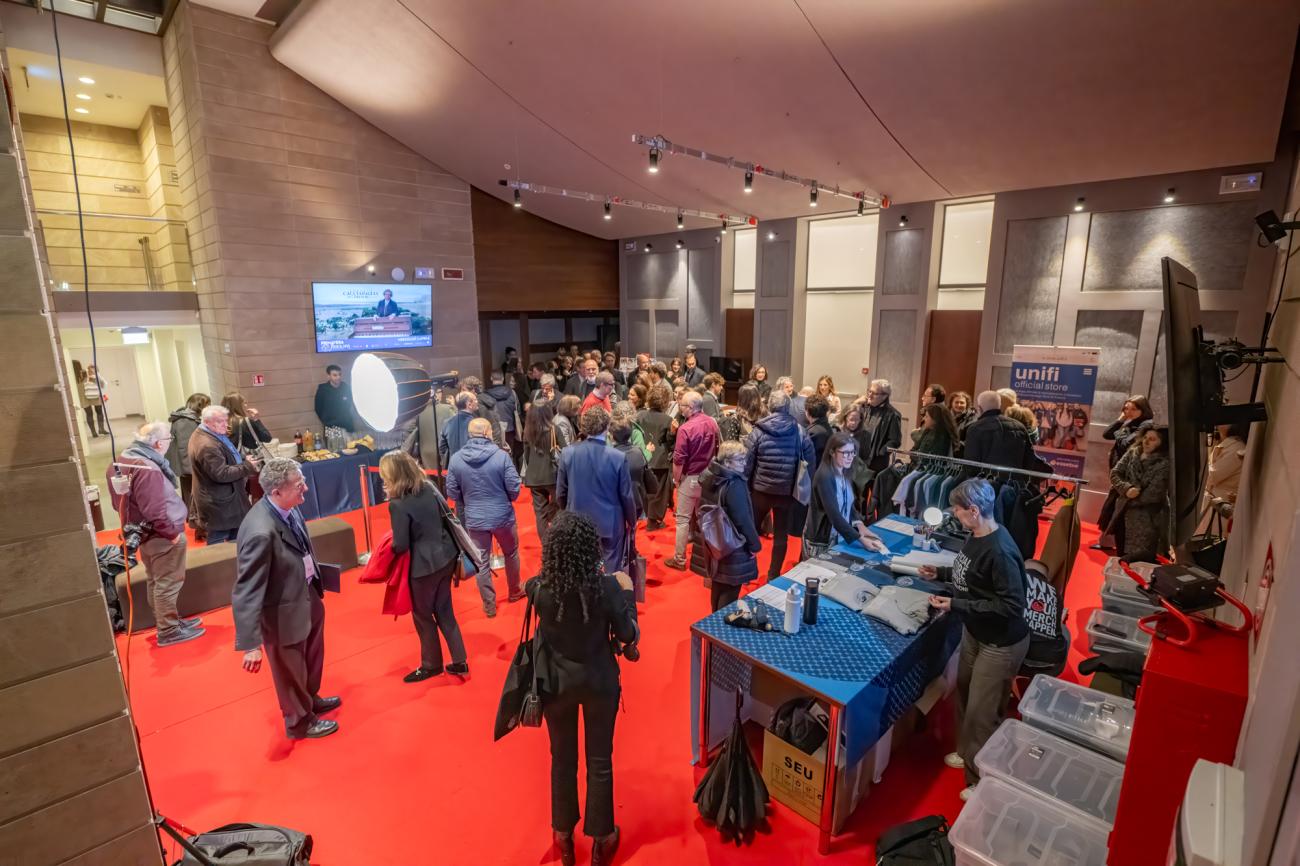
[111,492,1104,866]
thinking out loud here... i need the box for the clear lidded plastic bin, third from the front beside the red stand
[1021,674,1136,761]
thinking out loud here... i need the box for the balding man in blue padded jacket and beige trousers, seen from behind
[447,417,524,616]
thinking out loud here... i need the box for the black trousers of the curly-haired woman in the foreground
[542,689,619,836]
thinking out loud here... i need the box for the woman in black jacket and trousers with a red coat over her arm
[380,451,469,683]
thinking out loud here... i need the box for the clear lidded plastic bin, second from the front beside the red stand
[975,719,1125,833]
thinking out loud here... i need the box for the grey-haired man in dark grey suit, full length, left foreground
[230,458,343,740]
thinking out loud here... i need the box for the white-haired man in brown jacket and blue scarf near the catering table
[190,404,261,545]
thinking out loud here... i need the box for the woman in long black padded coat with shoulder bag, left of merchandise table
[696,442,762,610]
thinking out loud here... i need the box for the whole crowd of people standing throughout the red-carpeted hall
[104,346,1190,863]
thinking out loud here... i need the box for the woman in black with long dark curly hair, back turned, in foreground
[525,511,637,866]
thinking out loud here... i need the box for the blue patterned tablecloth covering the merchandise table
[690,515,961,766]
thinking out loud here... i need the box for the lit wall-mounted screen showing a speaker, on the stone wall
[312,282,433,352]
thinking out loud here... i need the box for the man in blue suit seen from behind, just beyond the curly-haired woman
[555,406,637,575]
